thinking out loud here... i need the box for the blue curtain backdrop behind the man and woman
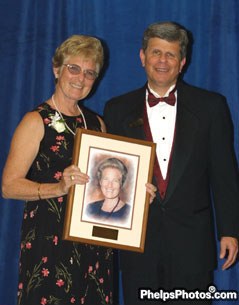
[0,0,239,305]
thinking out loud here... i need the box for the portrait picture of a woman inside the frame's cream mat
[82,149,138,229]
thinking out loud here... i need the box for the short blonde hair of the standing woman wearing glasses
[52,35,104,72]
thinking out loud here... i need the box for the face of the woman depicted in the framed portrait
[100,167,122,199]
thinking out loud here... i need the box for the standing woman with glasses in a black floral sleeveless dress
[2,35,113,305]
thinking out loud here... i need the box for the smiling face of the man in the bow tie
[140,38,186,95]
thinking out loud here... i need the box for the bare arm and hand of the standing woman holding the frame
[2,112,82,200]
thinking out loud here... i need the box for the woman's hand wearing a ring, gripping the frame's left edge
[59,165,90,194]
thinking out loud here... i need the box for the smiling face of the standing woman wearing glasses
[53,56,97,100]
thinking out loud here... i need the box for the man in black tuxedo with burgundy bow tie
[104,22,239,305]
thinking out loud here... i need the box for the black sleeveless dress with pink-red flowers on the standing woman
[18,103,113,305]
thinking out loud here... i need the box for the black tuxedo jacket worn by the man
[104,82,239,273]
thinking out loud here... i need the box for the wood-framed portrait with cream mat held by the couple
[63,129,156,252]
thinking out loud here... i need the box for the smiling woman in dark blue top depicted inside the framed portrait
[87,158,130,223]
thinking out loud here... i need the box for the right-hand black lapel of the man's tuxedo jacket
[163,86,199,204]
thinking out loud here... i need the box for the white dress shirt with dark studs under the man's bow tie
[146,85,177,179]
